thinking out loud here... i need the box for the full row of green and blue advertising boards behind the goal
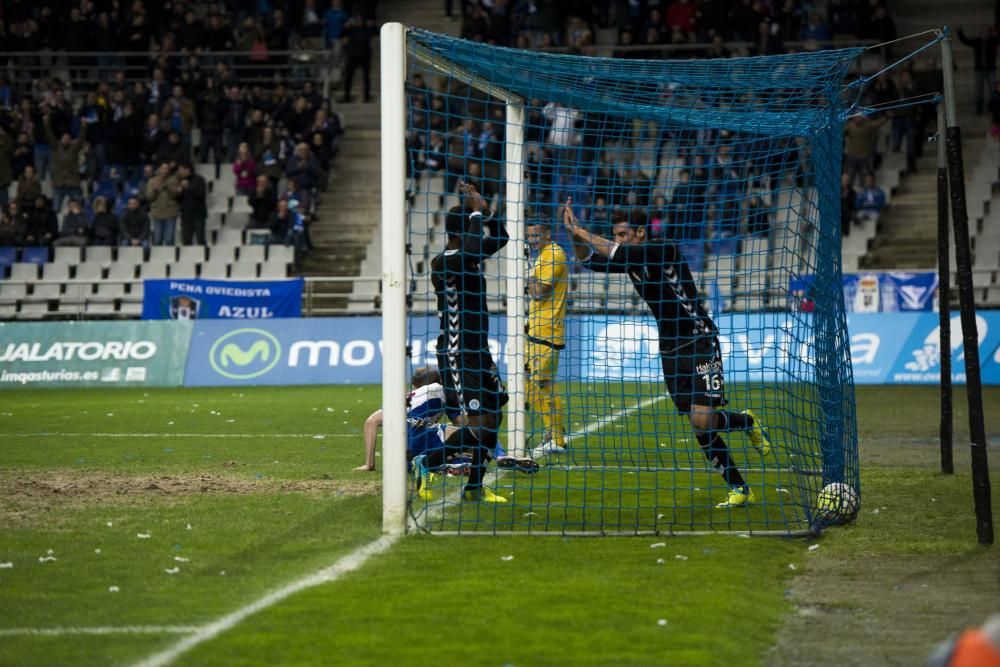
[0,311,1000,389]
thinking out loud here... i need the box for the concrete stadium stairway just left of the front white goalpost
[301,0,461,315]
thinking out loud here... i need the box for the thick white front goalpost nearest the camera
[380,23,409,534]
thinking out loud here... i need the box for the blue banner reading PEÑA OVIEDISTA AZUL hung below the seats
[142,278,303,320]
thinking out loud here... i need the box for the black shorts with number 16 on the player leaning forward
[660,336,726,413]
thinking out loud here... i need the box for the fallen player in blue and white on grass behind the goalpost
[354,366,538,482]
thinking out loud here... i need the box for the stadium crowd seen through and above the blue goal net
[408,0,908,262]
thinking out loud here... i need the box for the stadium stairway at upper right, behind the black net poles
[860,0,997,271]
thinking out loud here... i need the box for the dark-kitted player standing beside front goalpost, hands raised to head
[413,183,508,503]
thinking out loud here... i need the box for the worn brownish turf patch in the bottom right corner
[764,547,1000,667]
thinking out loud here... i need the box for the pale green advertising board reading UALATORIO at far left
[0,321,192,389]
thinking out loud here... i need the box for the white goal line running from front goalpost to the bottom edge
[135,535,399,667]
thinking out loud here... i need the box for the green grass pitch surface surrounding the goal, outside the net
[0,387,1000,665]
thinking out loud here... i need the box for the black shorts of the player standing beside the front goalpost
[438,352,508,415]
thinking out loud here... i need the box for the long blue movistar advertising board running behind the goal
[184,312,1000,386]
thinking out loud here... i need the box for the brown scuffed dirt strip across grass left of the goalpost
[0,470,377,523]
